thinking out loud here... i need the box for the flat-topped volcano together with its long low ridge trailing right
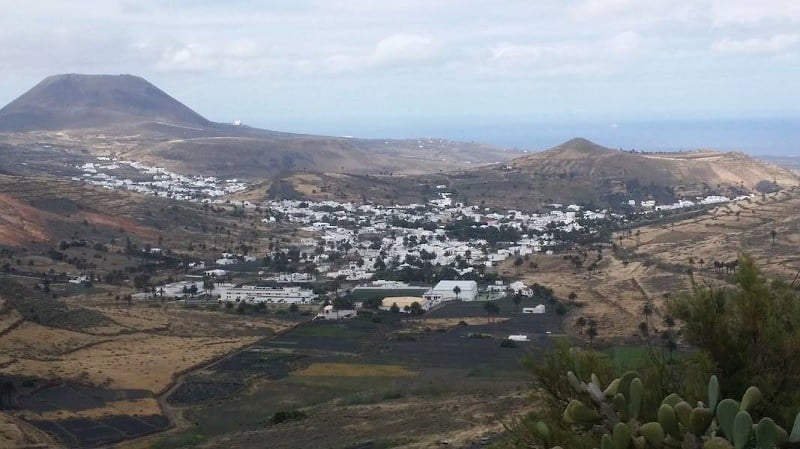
[0,74,516,178]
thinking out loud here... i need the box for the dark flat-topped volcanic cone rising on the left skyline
[0,74,212,131]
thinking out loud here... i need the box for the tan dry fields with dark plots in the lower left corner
[0,284,292,448]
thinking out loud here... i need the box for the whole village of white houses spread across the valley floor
[71,157,749,319]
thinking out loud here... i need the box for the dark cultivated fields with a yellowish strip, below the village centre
[124,301,560,449]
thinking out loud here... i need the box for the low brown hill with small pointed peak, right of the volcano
[274,138,800,210]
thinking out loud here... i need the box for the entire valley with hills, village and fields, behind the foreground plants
[0,75,800,449]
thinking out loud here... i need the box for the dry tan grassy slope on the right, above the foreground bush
[501,188,800,343]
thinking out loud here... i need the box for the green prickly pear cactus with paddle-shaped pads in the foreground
[535,371,800,449]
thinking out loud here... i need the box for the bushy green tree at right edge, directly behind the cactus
[669,255,800,425]
